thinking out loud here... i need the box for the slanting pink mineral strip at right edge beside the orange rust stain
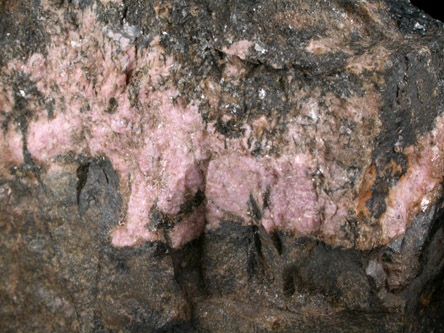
[380,116,444,242]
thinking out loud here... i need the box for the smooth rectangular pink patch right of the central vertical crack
[205,148,322,235]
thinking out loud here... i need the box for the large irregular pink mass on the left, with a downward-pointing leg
[1,10,208,247]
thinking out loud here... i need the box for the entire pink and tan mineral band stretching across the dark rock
[0,1,444,248]
